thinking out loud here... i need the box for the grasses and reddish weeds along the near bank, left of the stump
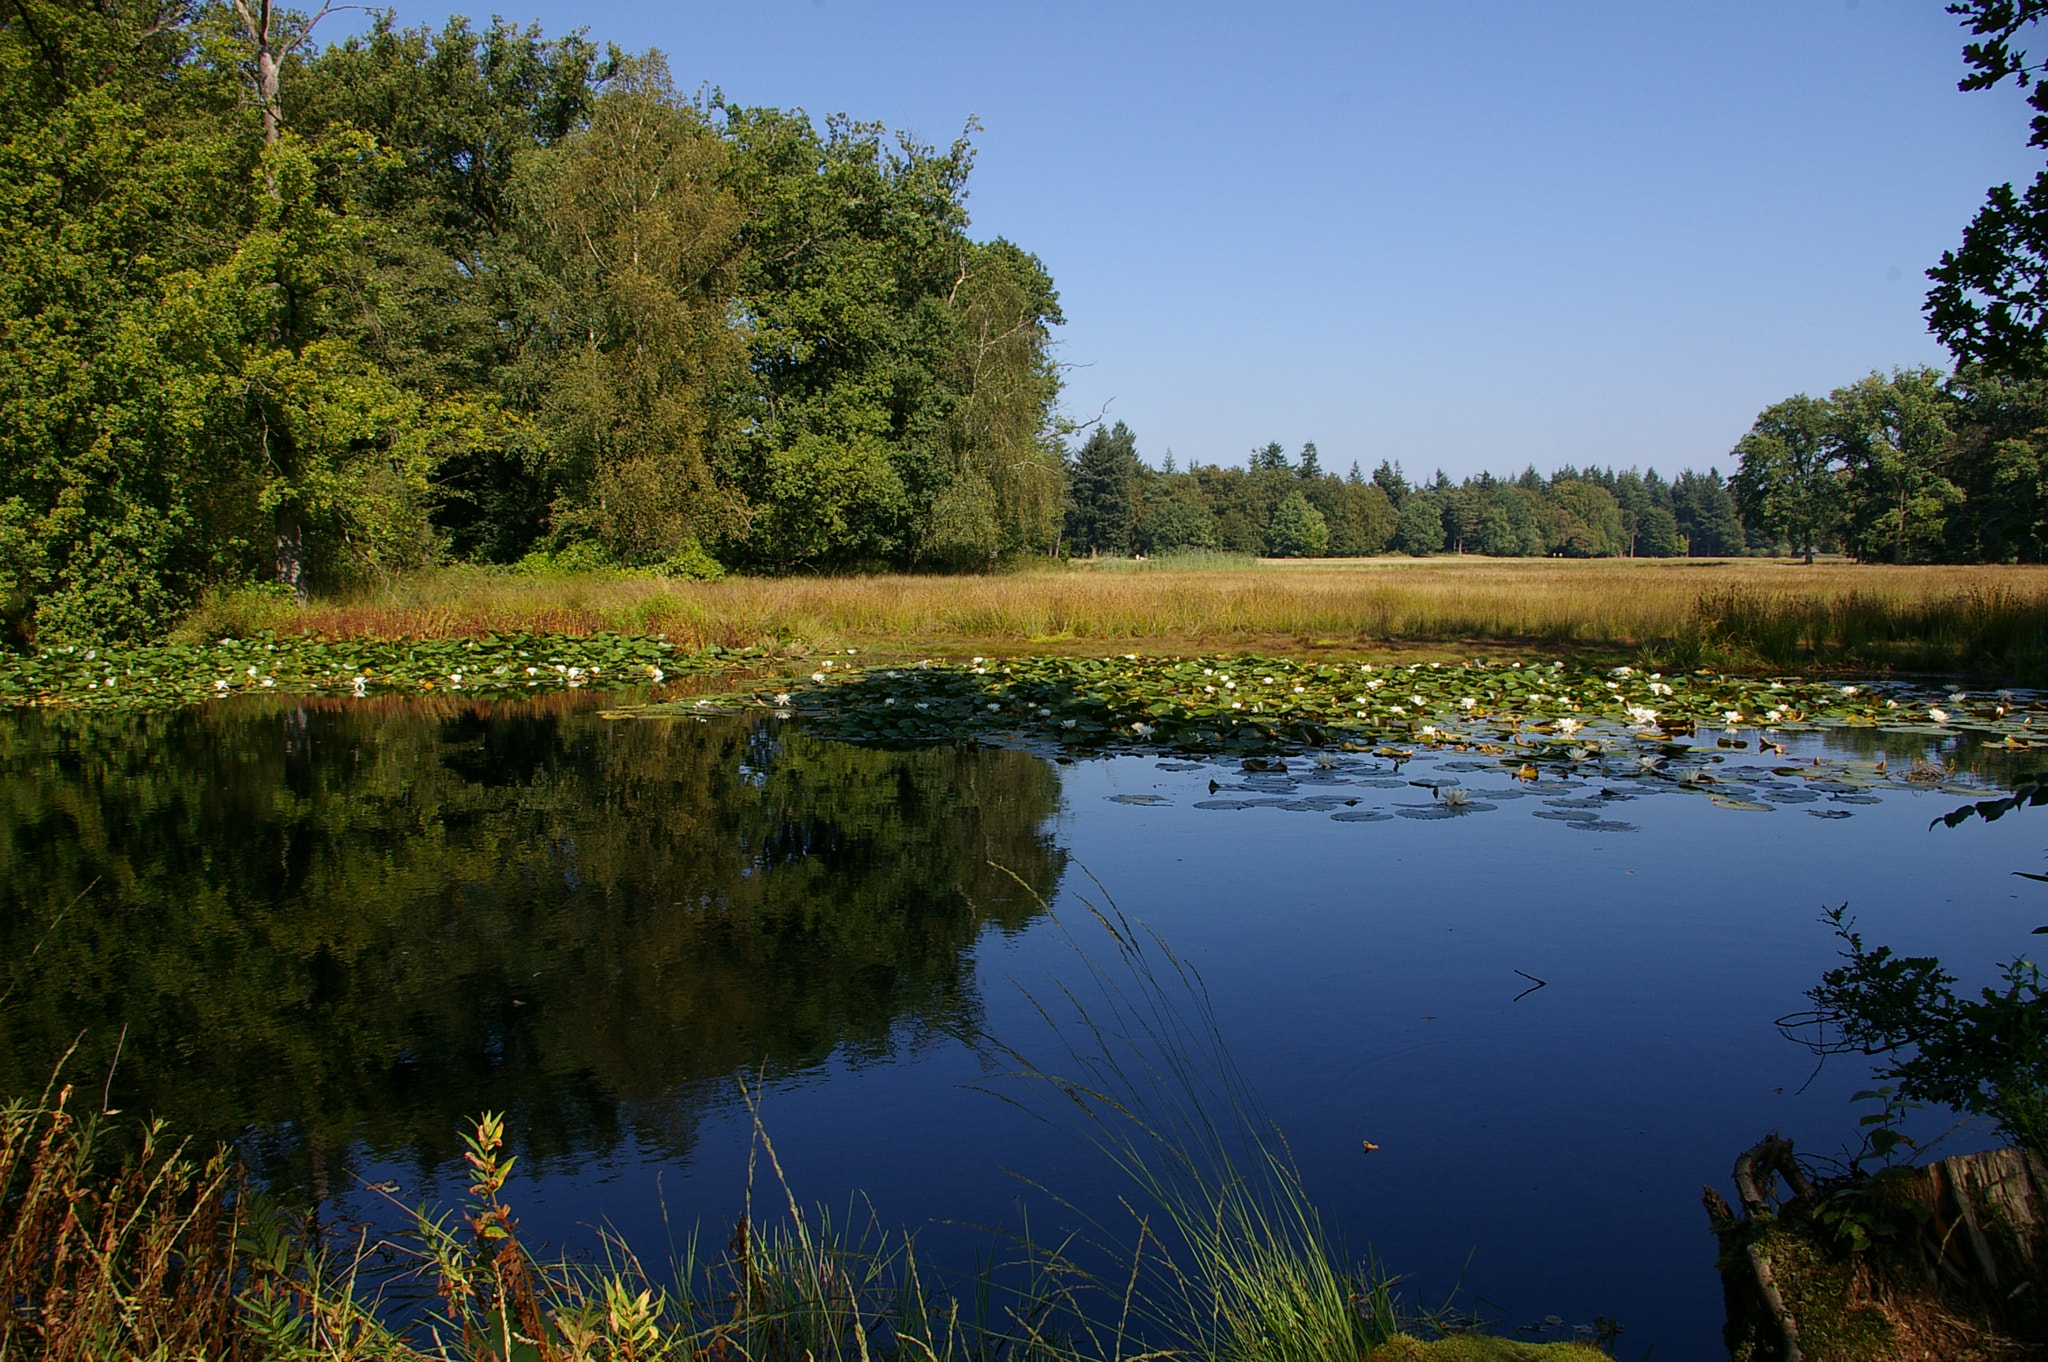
[0,901,1620,1362]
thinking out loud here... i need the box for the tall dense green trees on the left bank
[0,0,1063,641]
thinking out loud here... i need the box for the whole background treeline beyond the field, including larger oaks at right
[1067,365,2048,563]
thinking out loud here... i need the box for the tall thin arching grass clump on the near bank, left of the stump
[978,881,1403,1362]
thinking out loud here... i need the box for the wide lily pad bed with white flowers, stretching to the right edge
[708,655,2048,752]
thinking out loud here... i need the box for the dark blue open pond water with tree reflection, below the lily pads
[0,694,2048,1360]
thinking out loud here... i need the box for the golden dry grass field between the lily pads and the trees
[186,557,2048,676]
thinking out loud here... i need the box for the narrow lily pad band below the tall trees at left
[0,633,748,709]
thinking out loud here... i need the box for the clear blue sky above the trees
[336,0,2042,477]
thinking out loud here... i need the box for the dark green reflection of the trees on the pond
[0,696,1063,1188]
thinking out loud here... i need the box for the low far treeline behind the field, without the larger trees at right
[1065,422,1772,557]
